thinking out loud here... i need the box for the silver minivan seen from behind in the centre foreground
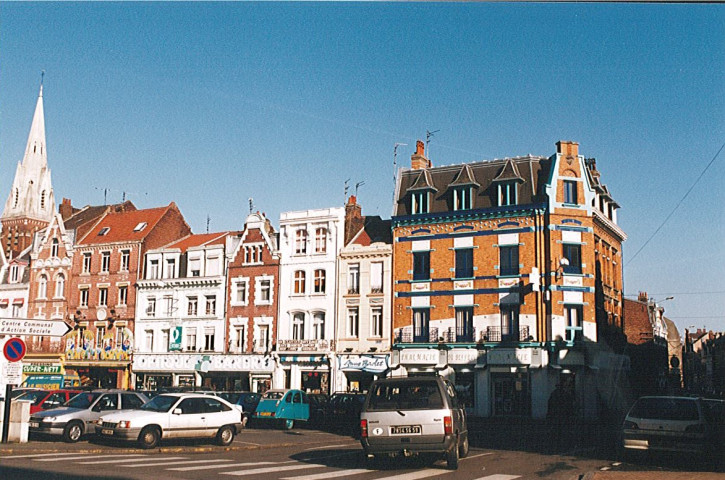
[360,377,468,470]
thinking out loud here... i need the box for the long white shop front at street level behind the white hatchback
[133,352,274,392]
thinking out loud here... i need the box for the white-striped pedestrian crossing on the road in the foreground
[0,452,520,480]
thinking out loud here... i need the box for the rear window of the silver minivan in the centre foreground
[369,382,443,410]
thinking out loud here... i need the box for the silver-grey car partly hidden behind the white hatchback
[29,390,148,443]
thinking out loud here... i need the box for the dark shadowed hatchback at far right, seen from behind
[621,396,715,455]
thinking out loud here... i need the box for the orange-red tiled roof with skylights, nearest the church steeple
[78,205,170,245]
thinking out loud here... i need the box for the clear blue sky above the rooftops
[0,2,725,331]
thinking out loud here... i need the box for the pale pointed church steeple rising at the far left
[0,81,55,252]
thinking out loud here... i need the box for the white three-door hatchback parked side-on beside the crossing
[95,393,242,448]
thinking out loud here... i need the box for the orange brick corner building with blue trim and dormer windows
[391,142,627,419]
